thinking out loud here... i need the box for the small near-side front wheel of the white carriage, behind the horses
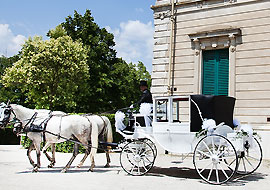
[120,140,156,175]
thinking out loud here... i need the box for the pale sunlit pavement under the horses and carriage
[0,145,270,190]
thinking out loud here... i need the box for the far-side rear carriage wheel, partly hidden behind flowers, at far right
[236,138,262,175]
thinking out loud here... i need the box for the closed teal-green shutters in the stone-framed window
[202,49,229,95]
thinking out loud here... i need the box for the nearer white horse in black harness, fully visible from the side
[0,104,98,172]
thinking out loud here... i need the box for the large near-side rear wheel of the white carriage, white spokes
[193,135,238,184]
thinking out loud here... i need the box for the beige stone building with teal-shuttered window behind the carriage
[152,0,270,158]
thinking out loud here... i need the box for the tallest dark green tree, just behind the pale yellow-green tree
[62,10,117,112]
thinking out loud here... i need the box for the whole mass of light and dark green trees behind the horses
[0,10,151,113]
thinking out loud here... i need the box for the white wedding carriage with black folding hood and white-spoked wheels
[116,95,262,184]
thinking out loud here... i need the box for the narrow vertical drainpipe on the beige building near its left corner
[167,0,175,96]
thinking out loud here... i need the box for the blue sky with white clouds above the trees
[0,0,155,72]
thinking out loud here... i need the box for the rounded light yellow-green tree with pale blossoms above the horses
[2,36,89,111]
